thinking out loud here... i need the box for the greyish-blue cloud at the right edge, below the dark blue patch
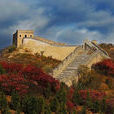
[78,11,114,28]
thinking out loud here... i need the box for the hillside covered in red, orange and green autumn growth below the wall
[0,44,114,114]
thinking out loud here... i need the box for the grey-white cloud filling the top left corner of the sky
[0,0,29,21]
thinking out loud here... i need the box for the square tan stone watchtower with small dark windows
[13,30,34,47]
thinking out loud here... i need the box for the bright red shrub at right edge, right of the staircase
[93,59,114,76]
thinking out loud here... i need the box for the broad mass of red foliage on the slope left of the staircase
[0,62,59,94]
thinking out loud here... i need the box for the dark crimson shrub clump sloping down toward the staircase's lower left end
[21,65,60,90]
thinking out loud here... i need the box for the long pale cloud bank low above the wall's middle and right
[42,26,105,44]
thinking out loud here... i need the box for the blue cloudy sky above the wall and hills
[0,0,114,47]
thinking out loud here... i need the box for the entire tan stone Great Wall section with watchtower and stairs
[13,30,109,86]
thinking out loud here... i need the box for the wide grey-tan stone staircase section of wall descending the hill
[52,42,108,86]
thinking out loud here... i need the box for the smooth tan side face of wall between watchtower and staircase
[23,38,76,61]
